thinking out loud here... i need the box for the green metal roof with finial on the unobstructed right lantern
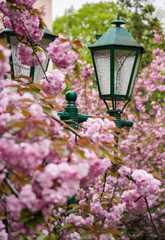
[89,15,142,49]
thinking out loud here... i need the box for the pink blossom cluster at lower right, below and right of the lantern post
[118,166,161,211]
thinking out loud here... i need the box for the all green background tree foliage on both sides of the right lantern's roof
[53,0,165,69]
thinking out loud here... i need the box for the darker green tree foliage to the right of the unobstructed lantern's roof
[117,0,165,69]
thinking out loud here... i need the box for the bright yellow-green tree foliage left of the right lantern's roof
[53,2,118,62]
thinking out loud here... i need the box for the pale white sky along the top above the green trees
[52,0,165,20]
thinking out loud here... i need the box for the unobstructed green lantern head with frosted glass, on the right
[89,15,144,110]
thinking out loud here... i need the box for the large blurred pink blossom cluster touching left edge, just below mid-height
[0,133,50,174]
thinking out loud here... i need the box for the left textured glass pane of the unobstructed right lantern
[94,49,111,95]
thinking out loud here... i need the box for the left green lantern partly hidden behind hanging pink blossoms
[0,27,57,82]
